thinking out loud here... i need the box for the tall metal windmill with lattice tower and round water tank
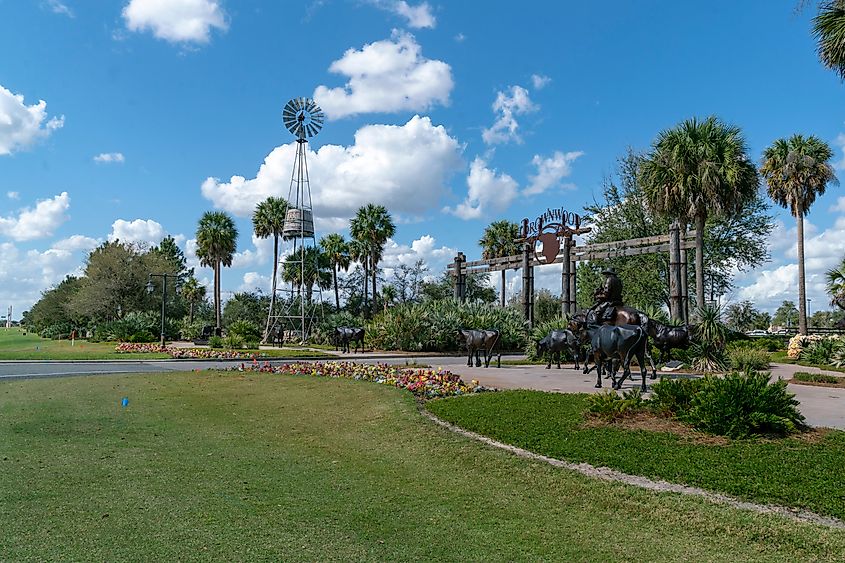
[274,98,325,344]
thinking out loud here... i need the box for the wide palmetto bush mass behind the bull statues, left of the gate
[366,300,525,352]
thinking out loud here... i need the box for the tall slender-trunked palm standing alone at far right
[760,135,836,334]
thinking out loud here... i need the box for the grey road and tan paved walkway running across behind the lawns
[0,360,845,430]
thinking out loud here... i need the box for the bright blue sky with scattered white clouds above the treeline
[0,0,845,318]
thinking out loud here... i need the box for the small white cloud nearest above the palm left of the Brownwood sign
[444,157,519,223]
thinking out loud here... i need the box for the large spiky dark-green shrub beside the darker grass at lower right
[682,372,804,438]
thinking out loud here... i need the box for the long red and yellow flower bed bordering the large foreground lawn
[233,362,490,399]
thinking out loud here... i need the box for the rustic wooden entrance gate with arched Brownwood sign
[448,208,695,327]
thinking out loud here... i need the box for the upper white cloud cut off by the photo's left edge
[0,86,65,156]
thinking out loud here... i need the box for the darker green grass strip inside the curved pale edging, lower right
[428,391,845,518]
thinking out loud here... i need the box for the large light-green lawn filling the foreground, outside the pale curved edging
[0,372,845,561]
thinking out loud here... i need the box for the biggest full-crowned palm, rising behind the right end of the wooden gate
[639,116,760,309]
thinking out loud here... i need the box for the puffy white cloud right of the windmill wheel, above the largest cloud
[314,30,454,119]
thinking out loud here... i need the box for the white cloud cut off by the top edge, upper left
[123,0,228,43]
